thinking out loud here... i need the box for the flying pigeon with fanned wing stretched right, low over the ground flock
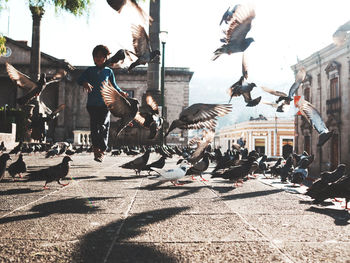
[165,103,232,136]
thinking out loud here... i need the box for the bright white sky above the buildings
[0,0,350,125]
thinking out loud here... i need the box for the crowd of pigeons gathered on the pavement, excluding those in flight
[0,138,350,208]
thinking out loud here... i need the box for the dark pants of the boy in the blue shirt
[86,106,111,151]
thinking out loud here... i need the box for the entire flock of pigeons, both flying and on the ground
[0,0,350,210]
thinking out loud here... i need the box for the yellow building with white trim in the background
[214,115,295,156]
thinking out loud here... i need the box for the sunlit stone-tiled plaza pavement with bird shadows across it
[0,153,350,262]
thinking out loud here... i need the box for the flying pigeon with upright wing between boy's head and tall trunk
[125,25,160,72]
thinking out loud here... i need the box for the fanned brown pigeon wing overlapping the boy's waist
[101,81,131,118]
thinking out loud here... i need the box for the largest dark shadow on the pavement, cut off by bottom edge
[72,207,189,263]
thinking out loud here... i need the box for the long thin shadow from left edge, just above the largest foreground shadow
[0,197,114,224]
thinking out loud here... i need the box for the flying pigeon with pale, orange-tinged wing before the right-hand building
[294,98,334,147]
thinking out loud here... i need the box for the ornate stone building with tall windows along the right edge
[292,35,350,173]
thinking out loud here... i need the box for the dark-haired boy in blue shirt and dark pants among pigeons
[78,45,127,162]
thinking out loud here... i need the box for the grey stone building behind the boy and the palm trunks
[0,38,193,145]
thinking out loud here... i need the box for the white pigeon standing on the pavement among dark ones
[149,160,190,186]
